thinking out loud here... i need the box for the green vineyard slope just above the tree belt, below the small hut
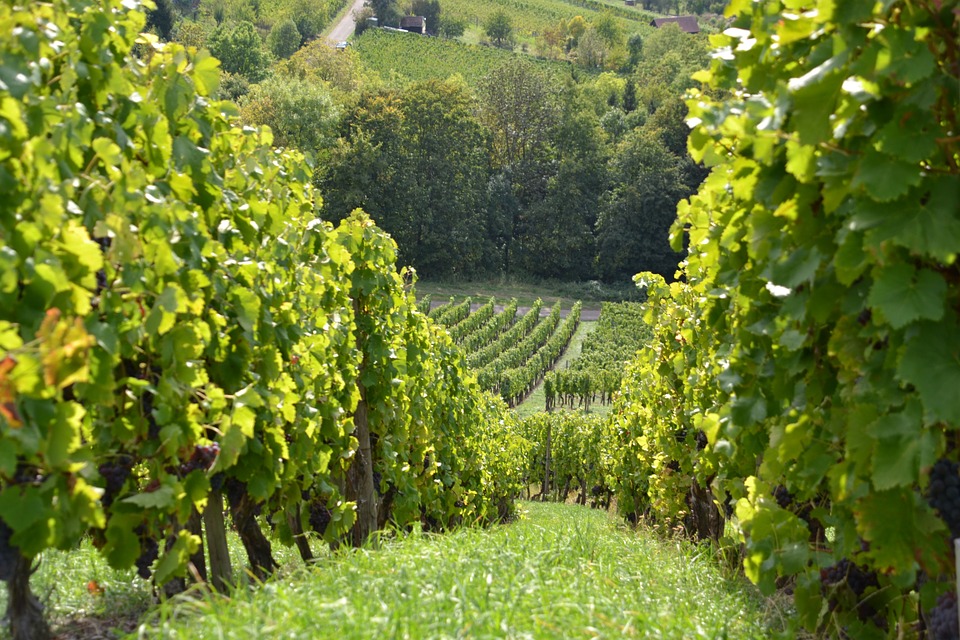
[354,29,571,85]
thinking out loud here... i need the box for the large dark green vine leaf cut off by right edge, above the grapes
[897,320,960,424]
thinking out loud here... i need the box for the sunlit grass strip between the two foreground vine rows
[139,503,792,639]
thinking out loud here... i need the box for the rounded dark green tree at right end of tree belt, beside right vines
[597,131,690,280]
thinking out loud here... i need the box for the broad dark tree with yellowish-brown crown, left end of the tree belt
[317,79,489,275]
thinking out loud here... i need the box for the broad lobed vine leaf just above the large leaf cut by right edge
[867,264,947,329]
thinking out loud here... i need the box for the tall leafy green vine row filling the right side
[622,0,960,638]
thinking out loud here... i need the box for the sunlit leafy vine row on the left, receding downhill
[0,0,524,624]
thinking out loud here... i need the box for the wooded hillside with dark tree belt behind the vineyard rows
[139,2,708,281]
